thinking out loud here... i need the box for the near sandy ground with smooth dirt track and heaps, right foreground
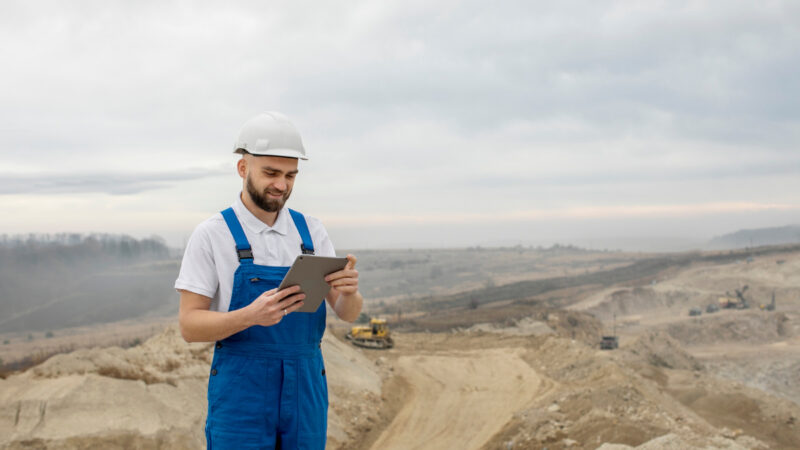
[340,331,800,449]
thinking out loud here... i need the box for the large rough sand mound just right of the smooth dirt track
[468,333,798,449]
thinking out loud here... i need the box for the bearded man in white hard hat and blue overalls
[175,112,363,450]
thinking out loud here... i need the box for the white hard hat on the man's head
[233,111,308,159]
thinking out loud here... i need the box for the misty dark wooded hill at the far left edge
[0,234,179,332]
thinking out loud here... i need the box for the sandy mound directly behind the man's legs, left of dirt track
[0,326,381,449]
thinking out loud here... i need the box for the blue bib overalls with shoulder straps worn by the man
[206,208,328,450]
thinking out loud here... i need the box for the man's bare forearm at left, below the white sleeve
[179,309,251,342]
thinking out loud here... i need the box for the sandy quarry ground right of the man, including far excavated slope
[334,248,800,449]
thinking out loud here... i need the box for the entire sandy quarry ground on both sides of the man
[0,246,800,450]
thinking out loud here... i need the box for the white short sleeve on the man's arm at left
[175,223,219,298]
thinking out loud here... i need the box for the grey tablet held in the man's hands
[278,255,347,312]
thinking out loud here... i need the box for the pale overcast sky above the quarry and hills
[0,0,800,248]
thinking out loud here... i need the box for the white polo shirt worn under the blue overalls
[175,196,336,312]
